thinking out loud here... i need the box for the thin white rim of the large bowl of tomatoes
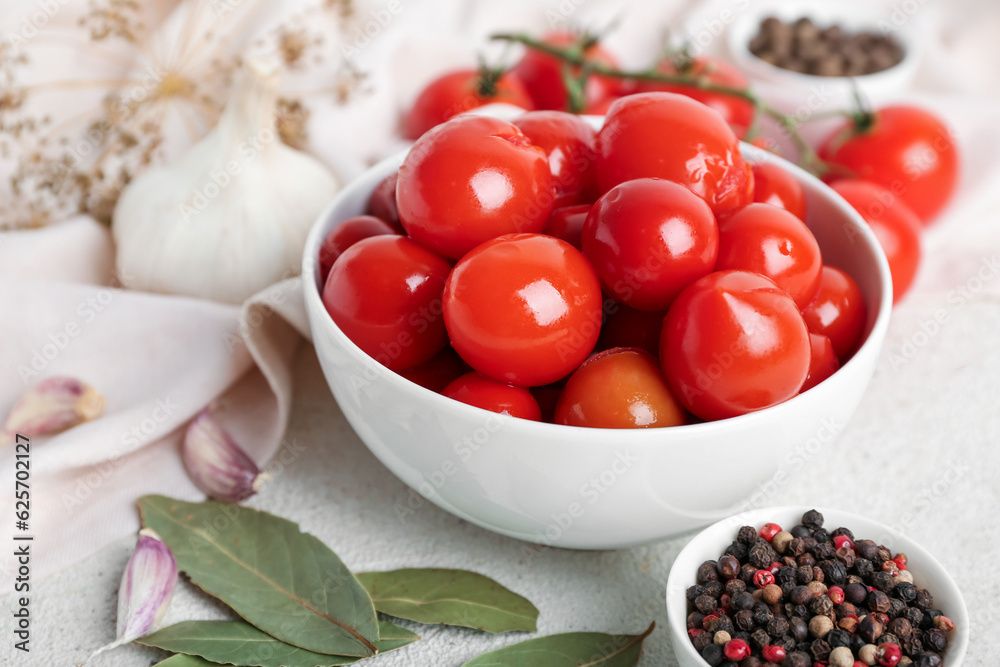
[302,128,893,447]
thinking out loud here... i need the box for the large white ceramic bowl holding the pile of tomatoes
[303,134,892,549]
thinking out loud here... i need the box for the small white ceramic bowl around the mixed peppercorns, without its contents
[667,507,970,667]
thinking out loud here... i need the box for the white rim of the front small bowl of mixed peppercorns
[666,505,971,667]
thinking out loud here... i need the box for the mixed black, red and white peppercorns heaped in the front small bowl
[687,510,955,667]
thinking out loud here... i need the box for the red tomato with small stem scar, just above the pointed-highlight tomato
[716,204,823,308]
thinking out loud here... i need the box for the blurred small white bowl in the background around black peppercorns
[726,0,921,113]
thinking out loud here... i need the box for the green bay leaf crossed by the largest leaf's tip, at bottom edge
[136,620,420,667]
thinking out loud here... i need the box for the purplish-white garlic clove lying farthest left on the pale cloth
[3,376,104,444]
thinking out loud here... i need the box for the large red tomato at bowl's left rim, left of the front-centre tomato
[323,236,451,371]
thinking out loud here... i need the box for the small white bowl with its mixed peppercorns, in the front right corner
[667,507,969,667]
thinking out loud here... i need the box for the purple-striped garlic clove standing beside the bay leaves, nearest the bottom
[88,528,177,660]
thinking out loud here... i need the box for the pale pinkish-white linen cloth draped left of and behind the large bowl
[0,0,1000,576]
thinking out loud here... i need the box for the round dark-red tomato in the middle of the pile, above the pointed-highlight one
[581,178,719,310]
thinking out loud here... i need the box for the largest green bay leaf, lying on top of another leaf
[139,496,378,658]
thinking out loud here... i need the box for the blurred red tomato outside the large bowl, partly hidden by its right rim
[831,179,921,303]
